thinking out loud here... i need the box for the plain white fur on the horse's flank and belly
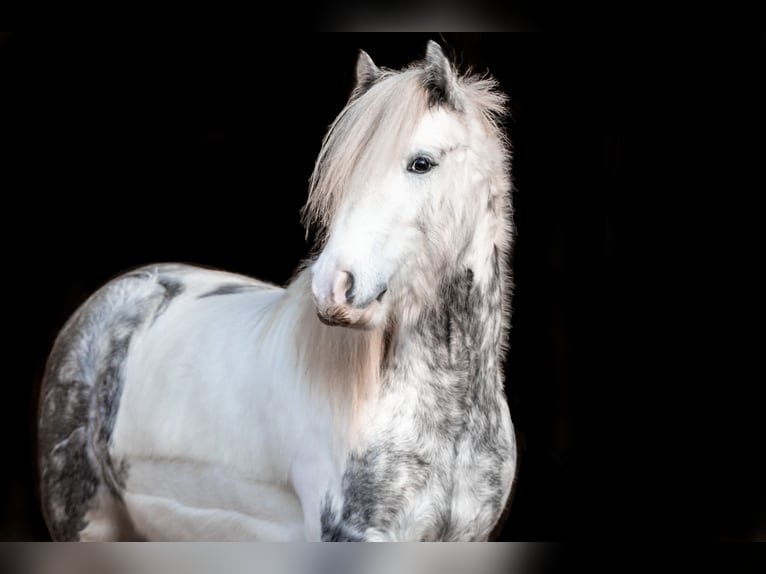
[106,270,342,540]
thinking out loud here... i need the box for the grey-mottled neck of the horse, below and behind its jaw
[383,197,511,402]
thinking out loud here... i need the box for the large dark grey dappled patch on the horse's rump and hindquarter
[38,272,183,540]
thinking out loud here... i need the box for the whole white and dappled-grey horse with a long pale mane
[37,41,517,541]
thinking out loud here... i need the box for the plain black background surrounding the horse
[0,33,766,540]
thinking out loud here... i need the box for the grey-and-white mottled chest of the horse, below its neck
[321,354,513,541]
